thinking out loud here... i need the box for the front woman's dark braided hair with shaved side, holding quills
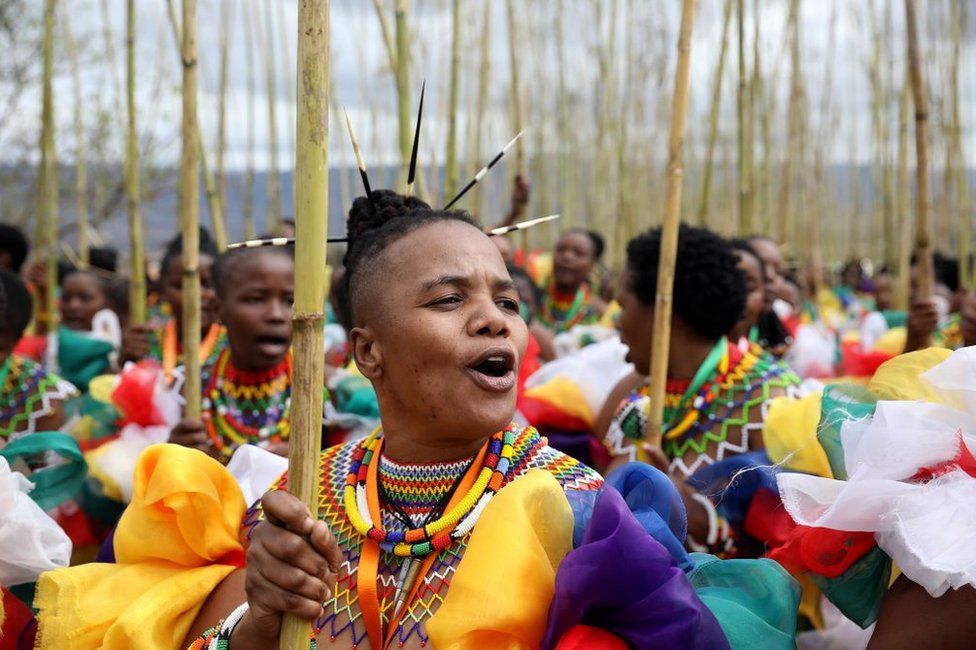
[340,190,478,326]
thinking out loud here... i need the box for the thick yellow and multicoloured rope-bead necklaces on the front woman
[343,425,515,558]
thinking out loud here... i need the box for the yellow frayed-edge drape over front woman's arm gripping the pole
[35,444,245,650]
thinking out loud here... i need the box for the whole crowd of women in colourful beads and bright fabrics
[0,179,976,649]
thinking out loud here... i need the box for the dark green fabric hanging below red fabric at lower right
[811,547,891,628]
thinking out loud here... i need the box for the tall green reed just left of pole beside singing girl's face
[125,0,145,324]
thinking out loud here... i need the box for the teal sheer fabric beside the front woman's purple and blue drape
[687,553,800,650]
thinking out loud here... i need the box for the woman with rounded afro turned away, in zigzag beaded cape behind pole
[603,224,800,556]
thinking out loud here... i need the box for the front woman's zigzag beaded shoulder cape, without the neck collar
[242,427,603,647]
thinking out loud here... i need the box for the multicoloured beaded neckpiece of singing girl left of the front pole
[203,348,291,458]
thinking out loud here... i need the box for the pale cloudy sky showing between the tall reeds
[0,0,976,170]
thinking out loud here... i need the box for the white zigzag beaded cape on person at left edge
[0,356,78,442]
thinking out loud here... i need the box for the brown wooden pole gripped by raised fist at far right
[905,0,935,300]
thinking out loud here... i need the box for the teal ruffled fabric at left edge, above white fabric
[0,432,88,510]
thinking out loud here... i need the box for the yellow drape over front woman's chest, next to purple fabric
[427,469,573,650]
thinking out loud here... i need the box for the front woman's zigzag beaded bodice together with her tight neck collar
[242,428,603,648]
